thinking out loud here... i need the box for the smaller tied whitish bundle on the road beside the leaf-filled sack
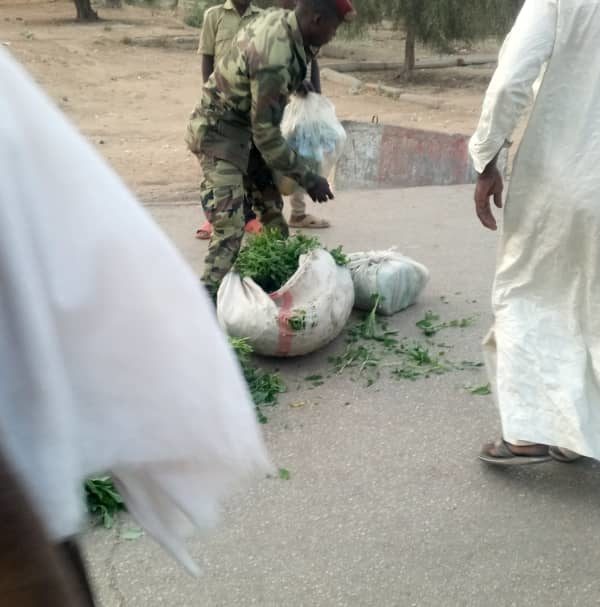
[348,249,429,316]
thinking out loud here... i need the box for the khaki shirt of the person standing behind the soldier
[198,0,261,63]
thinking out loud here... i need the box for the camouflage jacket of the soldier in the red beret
[186,10,316,189]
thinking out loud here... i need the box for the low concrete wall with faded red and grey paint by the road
[335,121,504,190]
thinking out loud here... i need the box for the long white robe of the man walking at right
[470,0,600,458]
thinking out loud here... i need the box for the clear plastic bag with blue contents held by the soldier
[281,93,346,195]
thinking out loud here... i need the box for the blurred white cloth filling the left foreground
[0,50,270,571]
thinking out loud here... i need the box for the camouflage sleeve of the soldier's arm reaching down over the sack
[250,65,318,190]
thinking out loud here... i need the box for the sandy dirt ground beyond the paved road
[0,0,493,202]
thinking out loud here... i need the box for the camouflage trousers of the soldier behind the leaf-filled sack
[199,152,289,296]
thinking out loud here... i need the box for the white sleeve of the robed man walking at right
[469,0,558,173]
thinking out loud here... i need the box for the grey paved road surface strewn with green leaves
[87,187,600,607]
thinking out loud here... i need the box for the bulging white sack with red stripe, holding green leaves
[217,249,354,357]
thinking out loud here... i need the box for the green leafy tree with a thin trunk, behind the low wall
[351,0,523,75]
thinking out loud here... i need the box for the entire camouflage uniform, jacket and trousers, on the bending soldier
[186,10,317,292]
